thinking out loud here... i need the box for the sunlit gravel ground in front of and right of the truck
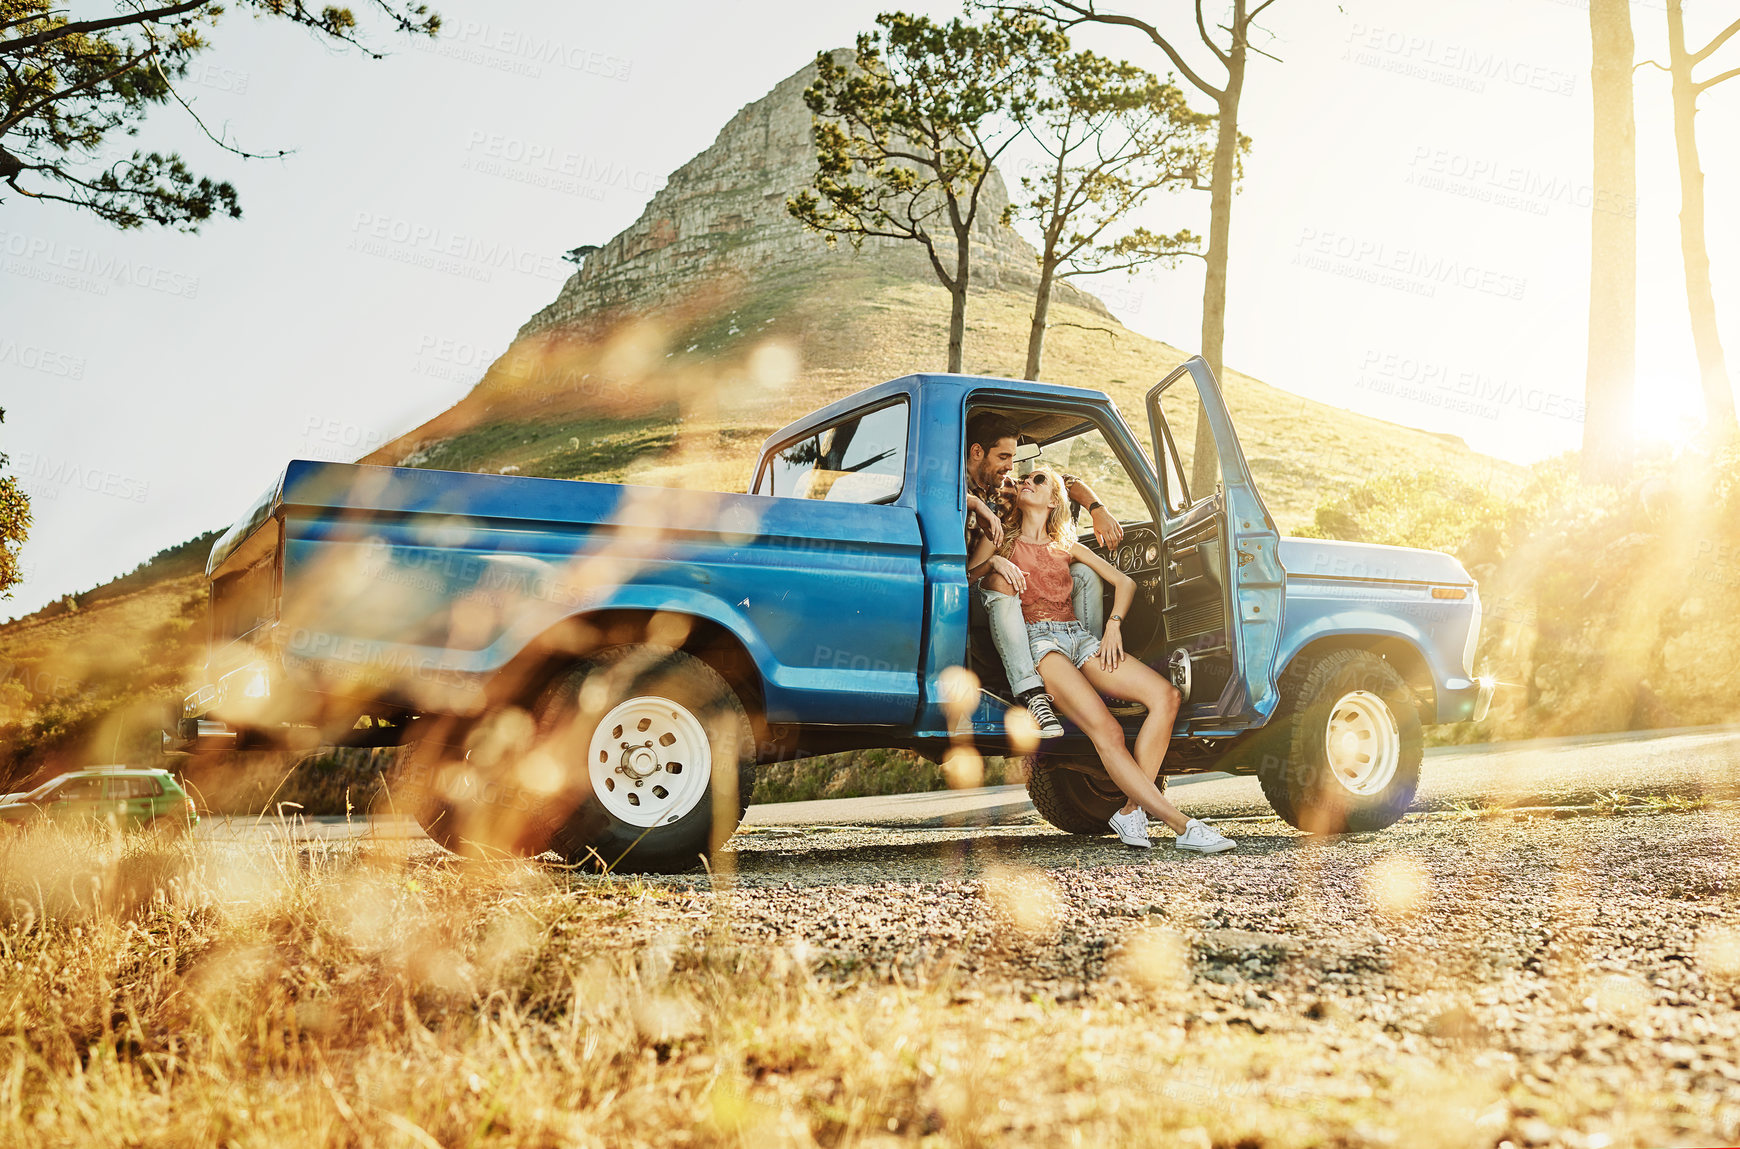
[525,801,1740,1149]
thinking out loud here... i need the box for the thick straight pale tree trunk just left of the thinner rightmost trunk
[1582,0,1637,484]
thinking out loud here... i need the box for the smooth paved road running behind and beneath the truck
[198,726,1740,841]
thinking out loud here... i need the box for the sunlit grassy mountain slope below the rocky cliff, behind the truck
[367,263,1521,529]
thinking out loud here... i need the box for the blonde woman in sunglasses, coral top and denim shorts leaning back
[967,467,1234,853]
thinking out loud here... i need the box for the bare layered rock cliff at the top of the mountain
[519,56,1105,338]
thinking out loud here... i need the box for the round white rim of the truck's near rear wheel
[586,695,713,827]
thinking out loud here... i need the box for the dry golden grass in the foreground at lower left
[0,829,1538,1147]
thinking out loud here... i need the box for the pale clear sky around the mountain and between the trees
[0,0,1740,618]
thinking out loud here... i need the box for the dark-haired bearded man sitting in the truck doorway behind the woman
[966,411,1124,738]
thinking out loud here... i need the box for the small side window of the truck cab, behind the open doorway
[755,400,907,503]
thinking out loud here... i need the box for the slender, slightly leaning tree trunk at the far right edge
[1667,0,1740,439]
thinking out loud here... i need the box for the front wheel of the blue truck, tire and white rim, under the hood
[1253,651,1423,834]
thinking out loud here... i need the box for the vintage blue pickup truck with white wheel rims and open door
[165,359,1493,869]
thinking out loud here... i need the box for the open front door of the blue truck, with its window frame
[1147,357,1286,735]
